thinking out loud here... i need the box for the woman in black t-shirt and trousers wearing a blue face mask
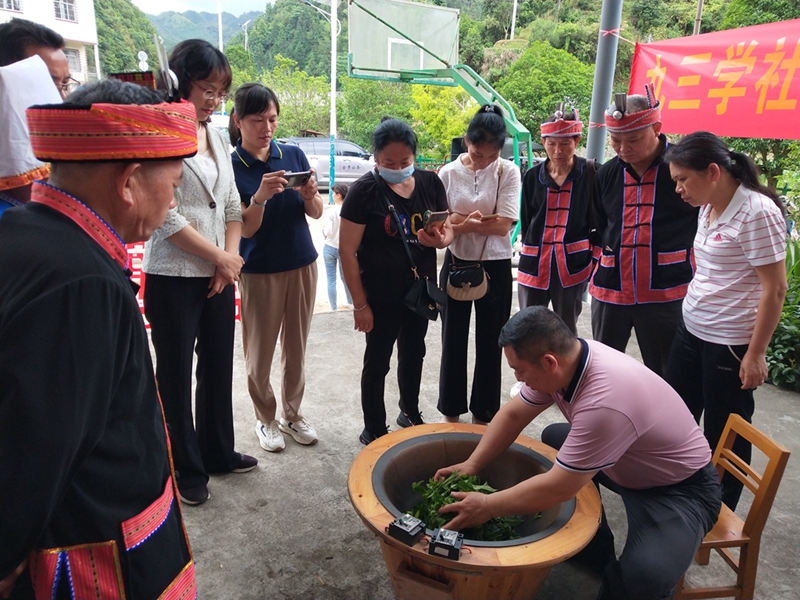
[339,119,453,444]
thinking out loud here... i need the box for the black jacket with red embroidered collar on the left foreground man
[0,183,197,600]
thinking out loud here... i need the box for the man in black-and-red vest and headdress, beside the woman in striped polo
[589,86,697,375]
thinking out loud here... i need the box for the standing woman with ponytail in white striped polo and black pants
[664,131,787,510]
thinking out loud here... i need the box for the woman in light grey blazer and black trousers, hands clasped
[142,40,258,504]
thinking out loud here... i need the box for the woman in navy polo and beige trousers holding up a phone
[231,83,322,452]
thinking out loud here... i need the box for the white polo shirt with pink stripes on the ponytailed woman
[683,185,786,345]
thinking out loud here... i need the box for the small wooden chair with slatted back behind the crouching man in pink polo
[674,415,790,600]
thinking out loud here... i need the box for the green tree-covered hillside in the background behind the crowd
[96,0,800,186]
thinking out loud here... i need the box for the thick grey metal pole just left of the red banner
[586,0,622,163]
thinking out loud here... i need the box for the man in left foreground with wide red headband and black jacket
[0,81,197,600]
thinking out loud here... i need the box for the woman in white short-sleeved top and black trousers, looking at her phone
[438,104,522,424]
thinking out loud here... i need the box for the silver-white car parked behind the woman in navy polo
[281,137,375,189]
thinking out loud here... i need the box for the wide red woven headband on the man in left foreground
[26,101,197,162]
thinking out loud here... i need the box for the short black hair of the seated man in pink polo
[497,306,576,363]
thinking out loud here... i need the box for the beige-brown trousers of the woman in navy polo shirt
[239,261,317,423]
